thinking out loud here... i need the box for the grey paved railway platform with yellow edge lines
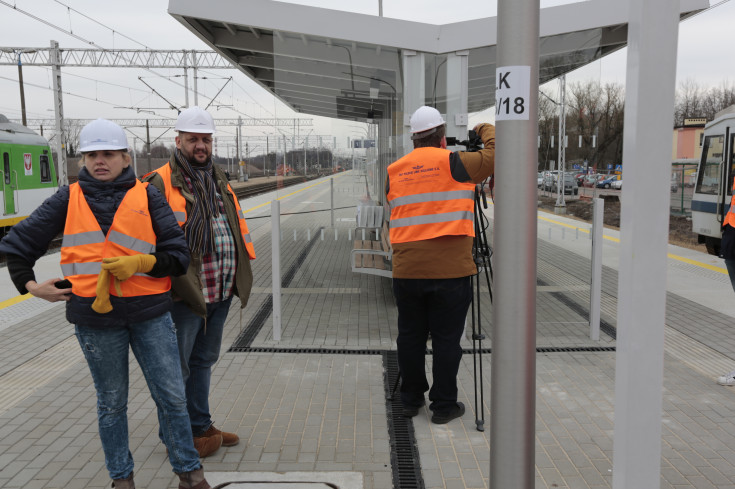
[0,172,735,489]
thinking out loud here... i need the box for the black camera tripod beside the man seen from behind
[387,182,493,431]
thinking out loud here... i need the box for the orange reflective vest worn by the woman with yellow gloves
[61,181,171,297]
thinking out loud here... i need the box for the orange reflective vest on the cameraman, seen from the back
[388,148,475,243]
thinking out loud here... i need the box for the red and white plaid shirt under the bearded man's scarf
[184,175,237,304]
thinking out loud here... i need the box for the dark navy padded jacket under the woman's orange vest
[0,167,189,326]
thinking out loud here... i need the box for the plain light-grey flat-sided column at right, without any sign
[613,0,679,489]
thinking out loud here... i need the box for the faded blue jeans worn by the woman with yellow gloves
[75,313,201,479]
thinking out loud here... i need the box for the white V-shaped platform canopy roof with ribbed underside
[169,0,709,121]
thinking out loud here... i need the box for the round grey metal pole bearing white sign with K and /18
[490,0,539,489]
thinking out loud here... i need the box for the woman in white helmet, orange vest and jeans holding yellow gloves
[0,119,210,489]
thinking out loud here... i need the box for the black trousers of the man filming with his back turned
[393,277,472,414]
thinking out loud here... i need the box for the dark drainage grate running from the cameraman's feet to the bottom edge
[383,351,425,489]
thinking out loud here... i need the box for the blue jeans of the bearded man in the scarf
[171,297,232,436]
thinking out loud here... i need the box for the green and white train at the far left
[0,114,58,236]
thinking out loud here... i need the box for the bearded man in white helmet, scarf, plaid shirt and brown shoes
[144,107,255,457]
